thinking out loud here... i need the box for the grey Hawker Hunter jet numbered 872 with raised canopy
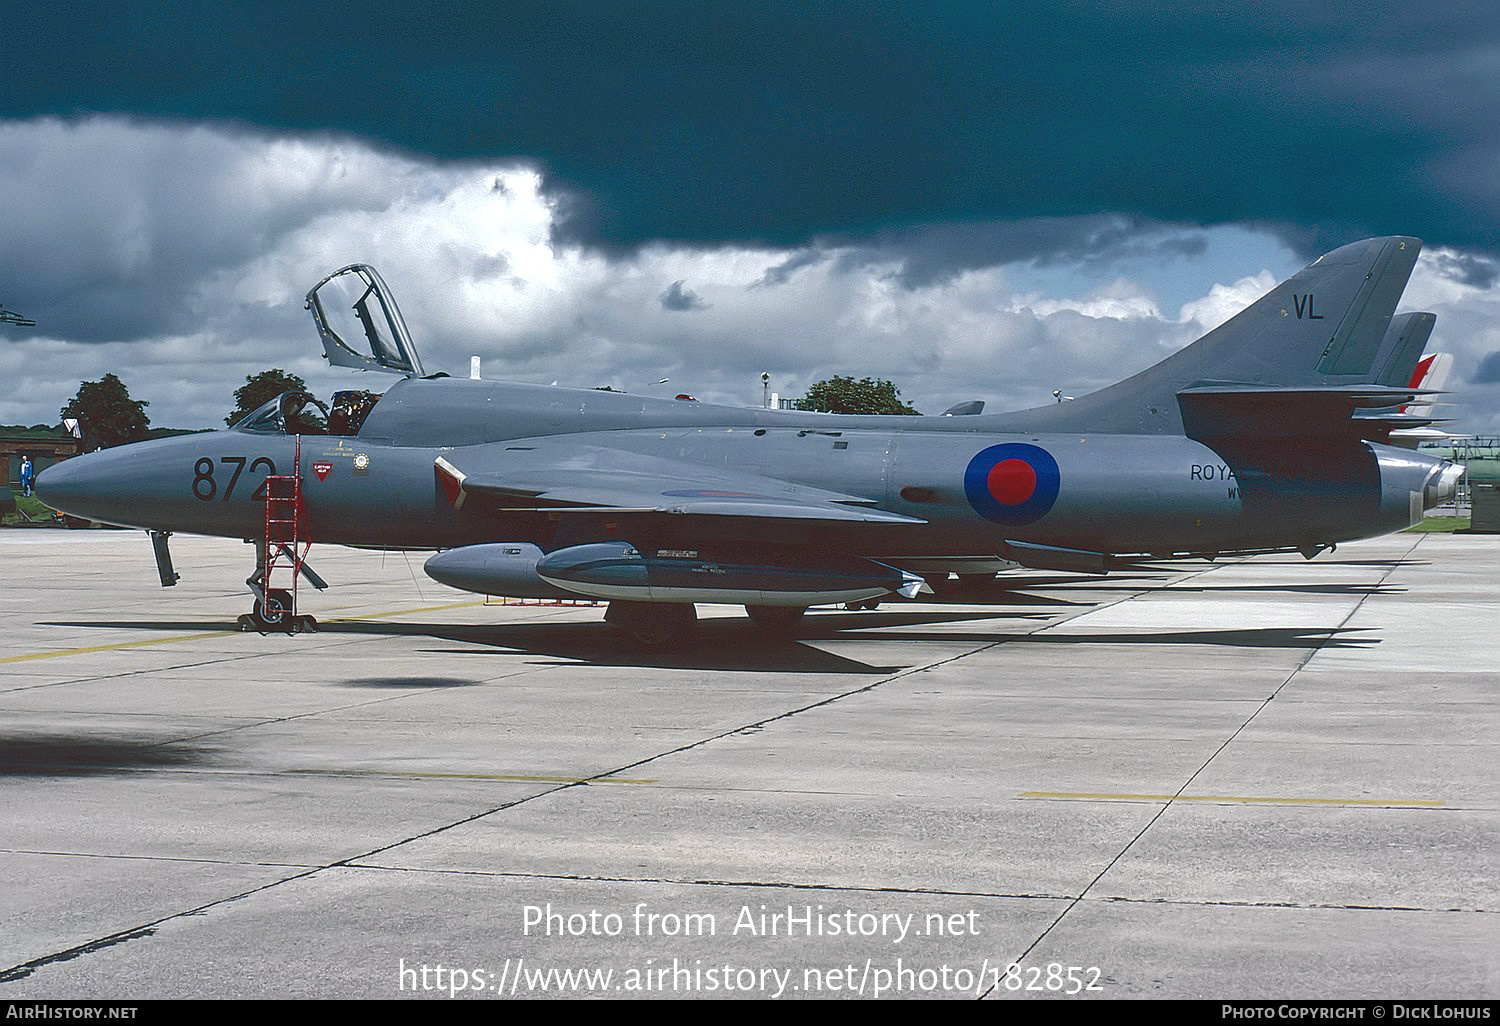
[38,237,1461,644]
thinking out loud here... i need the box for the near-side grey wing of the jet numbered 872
[434,440,924,524]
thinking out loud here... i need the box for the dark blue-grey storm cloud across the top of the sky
[11,0,1500,252]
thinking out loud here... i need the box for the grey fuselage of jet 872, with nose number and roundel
[42,381,1442,557]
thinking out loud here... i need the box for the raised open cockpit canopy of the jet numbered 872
[306,264,423,378]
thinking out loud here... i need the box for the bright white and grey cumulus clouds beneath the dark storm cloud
[0,117,1500,429]
